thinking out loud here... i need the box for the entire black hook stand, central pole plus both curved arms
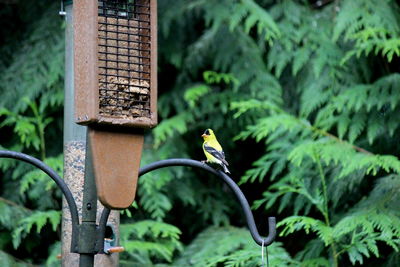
[0,150,276,266]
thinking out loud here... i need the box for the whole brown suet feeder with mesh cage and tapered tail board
[74,0,157,209]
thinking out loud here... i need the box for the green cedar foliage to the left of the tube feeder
[0,1,64,266]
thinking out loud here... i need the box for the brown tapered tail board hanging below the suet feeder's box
[89,128,144,209]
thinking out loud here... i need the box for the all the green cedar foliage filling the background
[0,0,400,266]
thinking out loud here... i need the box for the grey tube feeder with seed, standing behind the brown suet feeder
[61,0,119,267]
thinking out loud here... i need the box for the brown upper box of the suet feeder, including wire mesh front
[75,0,157,127]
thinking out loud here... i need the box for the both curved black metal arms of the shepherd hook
[0,150,276,266]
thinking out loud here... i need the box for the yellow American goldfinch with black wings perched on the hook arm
[201,129,230,173]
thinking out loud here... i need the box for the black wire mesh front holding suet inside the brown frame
[98,0,151,118]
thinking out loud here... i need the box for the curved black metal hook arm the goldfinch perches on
[100,159,276,246]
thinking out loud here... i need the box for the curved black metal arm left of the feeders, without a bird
[0,150,79,251]
